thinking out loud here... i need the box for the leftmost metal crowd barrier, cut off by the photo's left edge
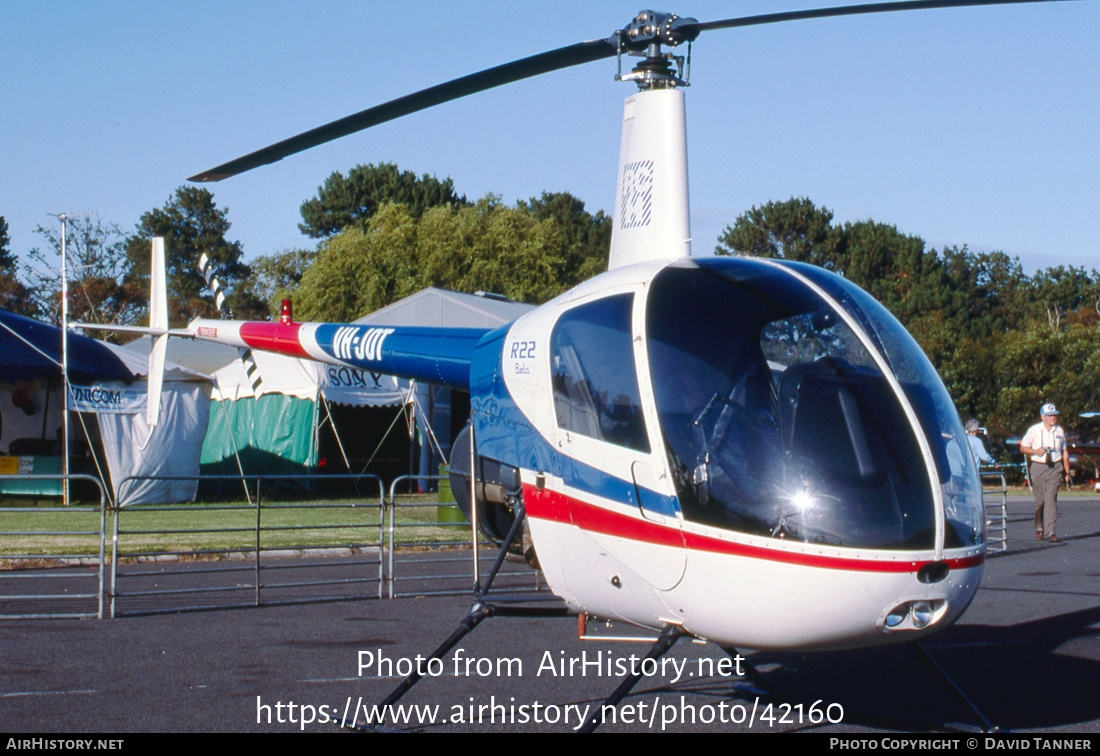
[0,474,108,620]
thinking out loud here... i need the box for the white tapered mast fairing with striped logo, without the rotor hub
[607,88,691,270]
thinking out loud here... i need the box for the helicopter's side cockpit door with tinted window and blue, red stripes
[550,291,685,590]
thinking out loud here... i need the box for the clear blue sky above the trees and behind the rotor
[0,0,1100,279]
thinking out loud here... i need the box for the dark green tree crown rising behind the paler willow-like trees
[298,163,468,239]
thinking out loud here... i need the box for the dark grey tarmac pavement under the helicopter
[0,496,1100,745]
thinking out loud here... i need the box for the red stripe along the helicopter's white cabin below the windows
[524,484,986,572]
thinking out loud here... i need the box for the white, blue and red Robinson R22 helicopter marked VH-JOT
[83,0,1082,726]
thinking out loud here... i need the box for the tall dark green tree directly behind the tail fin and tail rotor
[127,186,265,327]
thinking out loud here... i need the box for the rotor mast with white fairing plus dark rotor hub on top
[607,11,699,270]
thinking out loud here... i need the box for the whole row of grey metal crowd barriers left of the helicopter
[0,475,542,618]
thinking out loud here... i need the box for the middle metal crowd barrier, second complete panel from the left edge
[110,475,385,617]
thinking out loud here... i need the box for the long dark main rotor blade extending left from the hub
[187,40,616,182]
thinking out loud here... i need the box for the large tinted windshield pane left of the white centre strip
[646,259,980,549]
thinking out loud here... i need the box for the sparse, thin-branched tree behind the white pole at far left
[28,215,146,332]
